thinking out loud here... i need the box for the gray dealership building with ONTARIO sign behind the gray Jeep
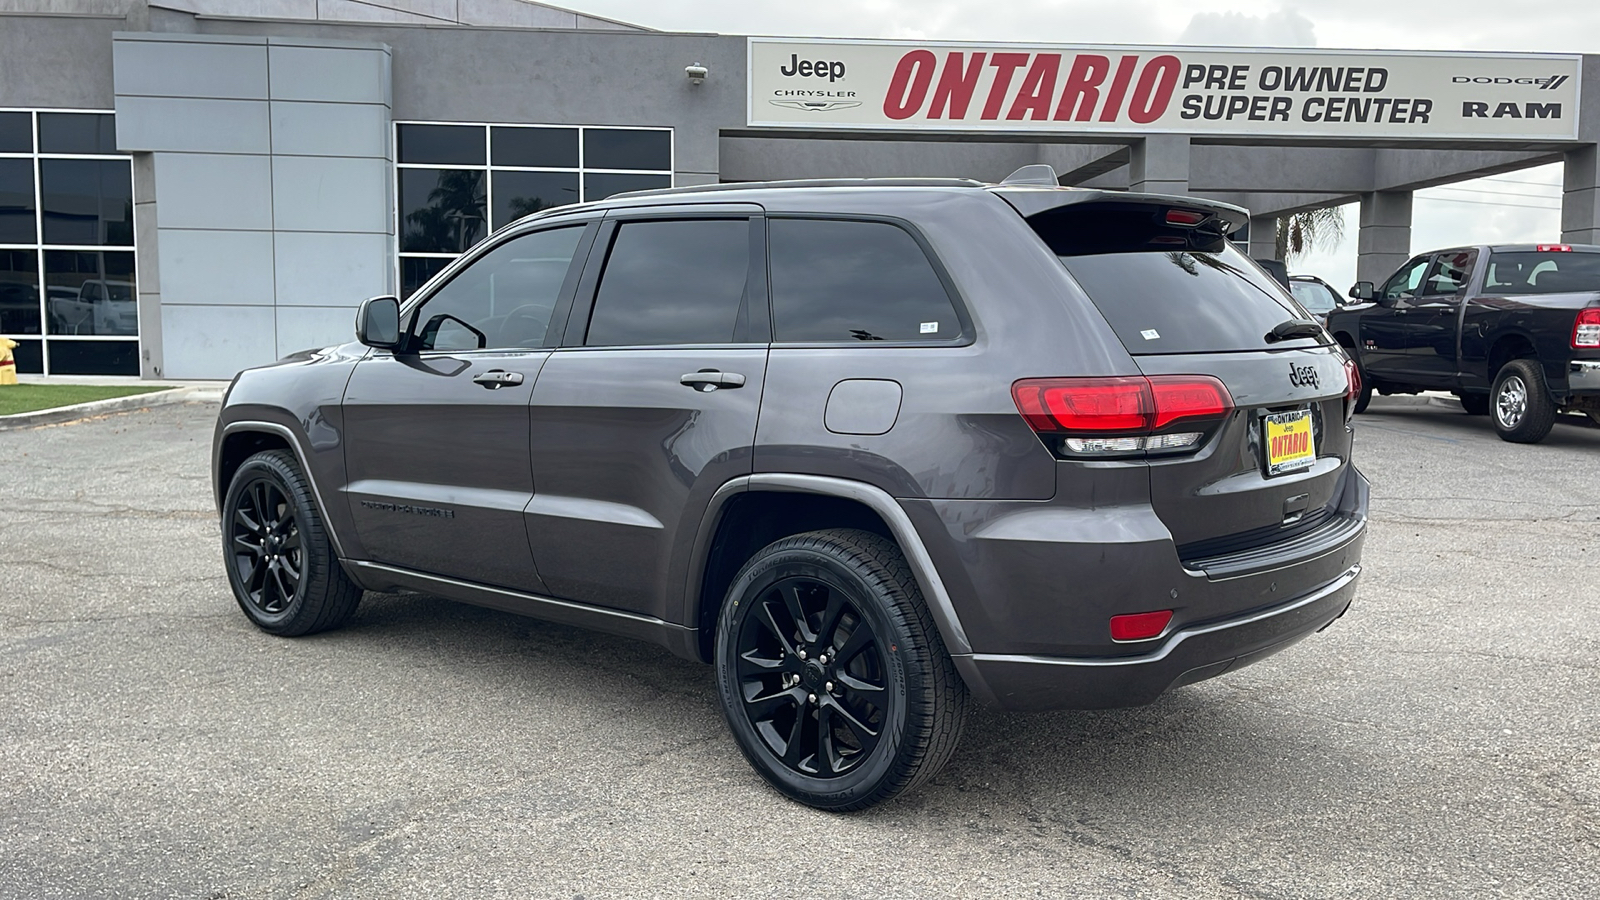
[0,0,1600,378]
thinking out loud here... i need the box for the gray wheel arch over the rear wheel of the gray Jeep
[683,472,971,663]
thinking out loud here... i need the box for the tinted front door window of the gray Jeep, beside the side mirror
[414,226,584,351]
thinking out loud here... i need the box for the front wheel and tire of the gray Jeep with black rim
[222,450,362,637]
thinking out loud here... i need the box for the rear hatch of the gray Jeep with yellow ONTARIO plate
[1000,191,1358,577]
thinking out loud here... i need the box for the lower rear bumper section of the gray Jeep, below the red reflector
[955,565,1362,711]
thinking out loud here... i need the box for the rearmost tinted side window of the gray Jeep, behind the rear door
[766,219,962,343]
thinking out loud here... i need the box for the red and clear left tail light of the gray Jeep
[1011,375,1234,456]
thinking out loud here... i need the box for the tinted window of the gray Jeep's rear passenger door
[584,219,750,346]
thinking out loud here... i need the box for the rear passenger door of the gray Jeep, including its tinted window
[528,205,770,618]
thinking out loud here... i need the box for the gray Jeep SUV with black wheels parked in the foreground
[214,171,1368,810]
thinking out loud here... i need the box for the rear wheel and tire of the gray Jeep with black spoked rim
[715,528,968,812]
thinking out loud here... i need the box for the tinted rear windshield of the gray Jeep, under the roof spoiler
[1027,203,1320,356]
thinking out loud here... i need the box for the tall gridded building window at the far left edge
[0,109,139,375]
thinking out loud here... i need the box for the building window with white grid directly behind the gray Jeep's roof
[403,122,672,298]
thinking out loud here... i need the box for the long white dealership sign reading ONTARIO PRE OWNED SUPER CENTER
[749,38,1582,139]
